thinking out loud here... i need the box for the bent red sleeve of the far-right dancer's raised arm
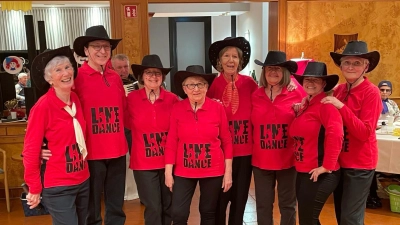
[339,92,382,141]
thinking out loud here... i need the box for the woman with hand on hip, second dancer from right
[290,62,343,225]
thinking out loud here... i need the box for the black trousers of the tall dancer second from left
[87,156,126,225]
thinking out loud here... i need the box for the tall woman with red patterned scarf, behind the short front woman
[207,37,257,225]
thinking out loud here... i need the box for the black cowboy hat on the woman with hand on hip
[293,62,339,92]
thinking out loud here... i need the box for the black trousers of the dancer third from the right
[253,167,296,225]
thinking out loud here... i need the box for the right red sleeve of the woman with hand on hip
[320,104,343,170]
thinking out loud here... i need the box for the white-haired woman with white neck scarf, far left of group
[22,46,89,225]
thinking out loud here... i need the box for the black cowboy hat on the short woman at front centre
[174,65,217,99]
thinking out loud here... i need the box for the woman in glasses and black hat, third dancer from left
[128,55,179,225]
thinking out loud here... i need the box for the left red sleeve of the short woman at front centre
[165,104,179,164]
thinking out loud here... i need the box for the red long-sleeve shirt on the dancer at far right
[334,77,382,170]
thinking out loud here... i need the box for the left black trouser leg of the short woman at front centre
[172,176,198,225]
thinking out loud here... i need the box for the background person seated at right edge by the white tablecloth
[378,80,400,121]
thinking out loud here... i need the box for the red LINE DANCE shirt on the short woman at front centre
[165,98,233,178]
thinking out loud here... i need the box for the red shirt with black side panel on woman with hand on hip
[289,92,343,173]
